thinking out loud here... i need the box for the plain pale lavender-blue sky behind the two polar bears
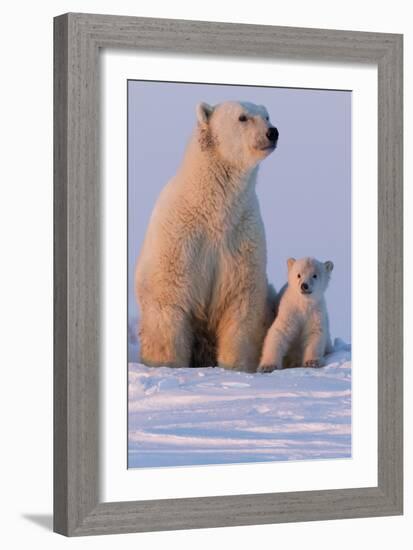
[128,81,351,342]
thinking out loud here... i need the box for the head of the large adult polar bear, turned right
[197,101,278,169]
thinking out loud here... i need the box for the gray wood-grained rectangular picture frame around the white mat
[54,14,403,536]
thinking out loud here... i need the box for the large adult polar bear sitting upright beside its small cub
[135,101,278,371]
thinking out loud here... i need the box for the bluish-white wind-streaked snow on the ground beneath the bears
[128,339,351,468]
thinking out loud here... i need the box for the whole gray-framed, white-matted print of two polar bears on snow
[54,14,403,536]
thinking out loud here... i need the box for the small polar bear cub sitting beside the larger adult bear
[258,258,334,372]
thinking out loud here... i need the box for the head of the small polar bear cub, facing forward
[287,258,334,298]
